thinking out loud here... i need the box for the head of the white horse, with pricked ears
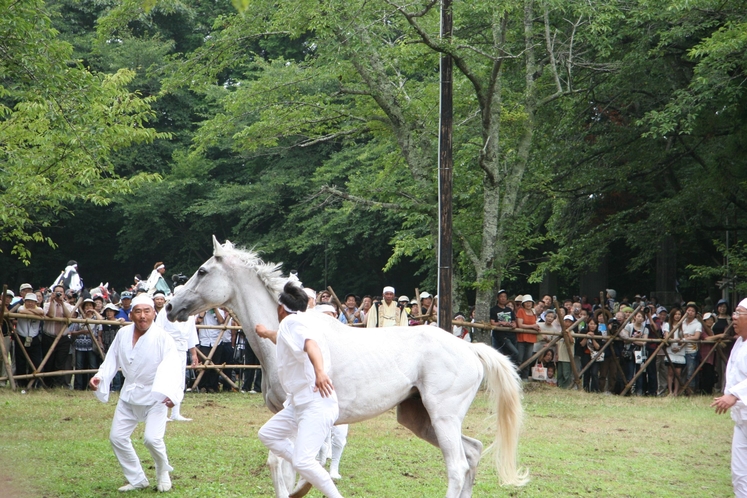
[166,236,236,321]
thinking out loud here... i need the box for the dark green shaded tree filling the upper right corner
[538,0,747,298]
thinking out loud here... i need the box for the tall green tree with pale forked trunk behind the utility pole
[164,1,600,317]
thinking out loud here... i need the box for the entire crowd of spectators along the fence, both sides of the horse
[0,261,731,396]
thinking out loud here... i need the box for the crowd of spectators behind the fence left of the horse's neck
[0,261,262,392]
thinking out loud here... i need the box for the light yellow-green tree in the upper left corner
[0,0,165,263]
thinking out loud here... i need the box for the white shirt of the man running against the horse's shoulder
[276,313,337,406]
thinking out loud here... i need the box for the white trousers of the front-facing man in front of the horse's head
[109,399,174,485]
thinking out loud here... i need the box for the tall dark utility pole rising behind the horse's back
[438,0,454,333]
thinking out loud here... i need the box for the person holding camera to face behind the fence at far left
[42,284,73,389]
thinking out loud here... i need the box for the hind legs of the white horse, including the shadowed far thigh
[397,398,474,498]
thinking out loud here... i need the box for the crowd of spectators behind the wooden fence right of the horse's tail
[490,289,733,396]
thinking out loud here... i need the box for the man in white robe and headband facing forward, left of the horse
[90,294,183,491]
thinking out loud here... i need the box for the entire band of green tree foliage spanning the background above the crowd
[0,0,747,312]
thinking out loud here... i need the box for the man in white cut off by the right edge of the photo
[711,299,747,498]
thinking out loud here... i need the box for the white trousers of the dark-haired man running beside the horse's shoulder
[259,398,342,498]
